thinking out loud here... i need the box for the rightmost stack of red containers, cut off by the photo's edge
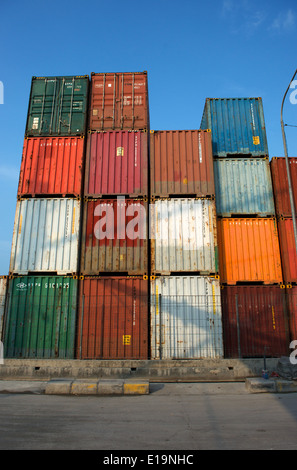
[270,157,297,341]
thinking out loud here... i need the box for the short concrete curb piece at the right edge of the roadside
[245,377,297,393]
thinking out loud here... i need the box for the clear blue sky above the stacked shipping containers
[0,0,297,275]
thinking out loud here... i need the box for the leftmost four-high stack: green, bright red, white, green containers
[4,76,89,358]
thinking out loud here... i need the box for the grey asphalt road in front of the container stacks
[0,383,297,452]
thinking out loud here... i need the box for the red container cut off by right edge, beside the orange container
[277,218,297,283]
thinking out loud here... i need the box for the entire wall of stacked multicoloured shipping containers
[0,72,297,359]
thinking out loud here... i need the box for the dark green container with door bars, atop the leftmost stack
[25,75,89,137]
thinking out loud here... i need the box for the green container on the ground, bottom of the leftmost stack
[4,276,78,359]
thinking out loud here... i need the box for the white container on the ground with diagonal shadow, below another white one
[150,276,223,359]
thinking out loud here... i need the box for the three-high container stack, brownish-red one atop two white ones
[150,130,223,359]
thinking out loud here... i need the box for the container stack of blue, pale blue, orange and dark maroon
[201,98,288,357]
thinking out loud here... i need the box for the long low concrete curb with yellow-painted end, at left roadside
[0,379,149,396]
